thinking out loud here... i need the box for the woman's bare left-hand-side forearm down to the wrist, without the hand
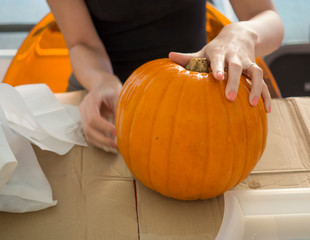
[47,0,118,90]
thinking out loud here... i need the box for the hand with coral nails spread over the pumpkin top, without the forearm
[169,22,271,112]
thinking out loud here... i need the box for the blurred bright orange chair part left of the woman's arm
[3,13,72,93]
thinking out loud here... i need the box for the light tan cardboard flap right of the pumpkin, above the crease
[252,98,310,174]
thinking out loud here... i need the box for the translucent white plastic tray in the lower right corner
[216,188,310,240]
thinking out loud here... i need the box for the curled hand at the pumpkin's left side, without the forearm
[79,74,122,152]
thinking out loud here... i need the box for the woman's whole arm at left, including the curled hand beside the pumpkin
[47,0,122,148]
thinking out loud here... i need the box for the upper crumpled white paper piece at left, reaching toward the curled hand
[0,83,87,155]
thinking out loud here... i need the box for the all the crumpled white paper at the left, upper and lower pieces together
[0,83,87,213]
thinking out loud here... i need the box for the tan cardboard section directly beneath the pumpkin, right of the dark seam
[136,181,224,240]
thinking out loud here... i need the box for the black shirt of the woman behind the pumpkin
[67,0,206,90]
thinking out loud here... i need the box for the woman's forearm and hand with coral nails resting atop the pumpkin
[169,0,284,112]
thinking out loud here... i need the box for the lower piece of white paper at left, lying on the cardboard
[0,106,56,213]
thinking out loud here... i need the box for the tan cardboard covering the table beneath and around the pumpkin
[0,92,310,240]
